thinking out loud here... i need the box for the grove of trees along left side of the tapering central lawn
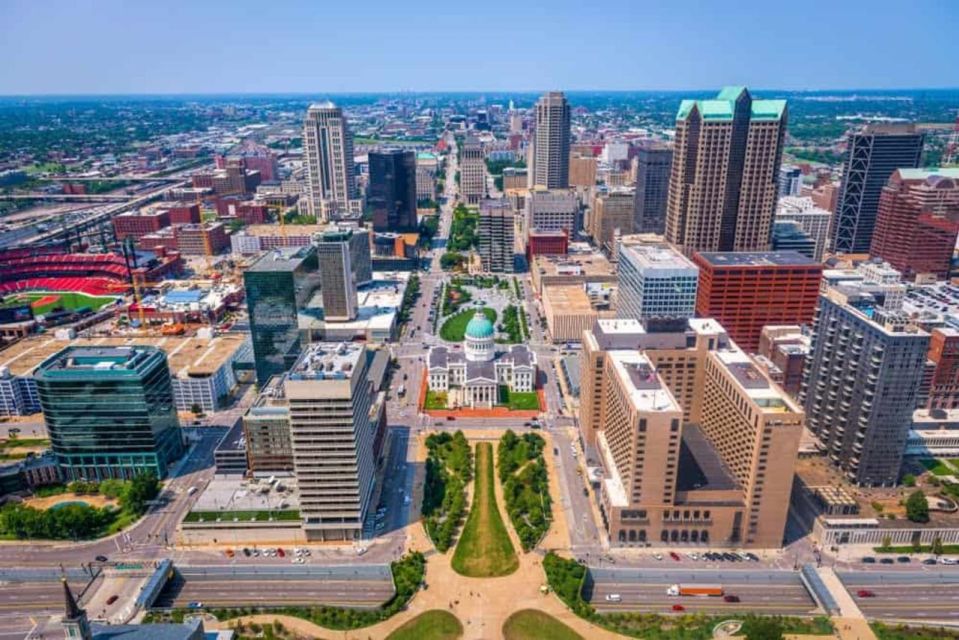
[422,431,473,553]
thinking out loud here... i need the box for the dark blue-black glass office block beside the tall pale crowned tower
[367,149,417,231]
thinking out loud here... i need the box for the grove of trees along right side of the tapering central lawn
[497,431,553,551]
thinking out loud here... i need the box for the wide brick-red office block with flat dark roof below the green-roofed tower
[693,251,822,353]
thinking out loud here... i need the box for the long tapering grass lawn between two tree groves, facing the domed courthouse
[453,442,519,578]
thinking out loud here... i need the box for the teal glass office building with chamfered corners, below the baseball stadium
[34,346,183,481]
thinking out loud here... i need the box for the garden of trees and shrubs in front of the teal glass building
[0,474,160,540]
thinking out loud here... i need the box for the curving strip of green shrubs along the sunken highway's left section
[143,551,426,630]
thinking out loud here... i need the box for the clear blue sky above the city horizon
[0,0,959,95]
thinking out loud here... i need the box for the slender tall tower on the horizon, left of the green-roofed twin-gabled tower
[530,91,570,189]
